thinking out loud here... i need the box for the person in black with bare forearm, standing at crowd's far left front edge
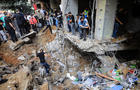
[5,13,18,42]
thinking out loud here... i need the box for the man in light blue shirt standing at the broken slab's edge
[79,17,90,41]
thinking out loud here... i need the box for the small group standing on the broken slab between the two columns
[66,10,90,41]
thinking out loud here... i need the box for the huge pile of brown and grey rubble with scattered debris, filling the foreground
[0,27,140,90]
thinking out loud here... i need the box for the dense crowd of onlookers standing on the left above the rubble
[0,9,63,42]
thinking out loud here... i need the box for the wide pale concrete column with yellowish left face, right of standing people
[95,0,117,40]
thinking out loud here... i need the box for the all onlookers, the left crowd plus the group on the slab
[0,9,90,42]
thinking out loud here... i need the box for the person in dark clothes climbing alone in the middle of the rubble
[36,49,50,74]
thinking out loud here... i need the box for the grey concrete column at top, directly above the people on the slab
[61,0,78,29]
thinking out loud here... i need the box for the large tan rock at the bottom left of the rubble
[4,67,32,90]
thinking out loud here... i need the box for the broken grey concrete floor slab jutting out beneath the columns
[64,32,139,55]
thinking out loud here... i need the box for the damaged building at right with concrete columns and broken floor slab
[61,0,139,58]
